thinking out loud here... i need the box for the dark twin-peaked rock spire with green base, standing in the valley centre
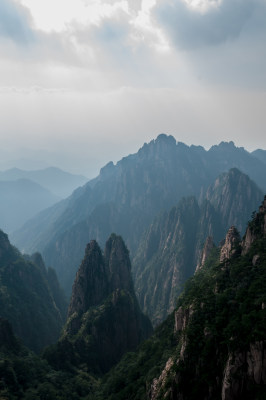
[45,234,152,373]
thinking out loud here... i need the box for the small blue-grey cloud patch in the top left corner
[0,0,34,44]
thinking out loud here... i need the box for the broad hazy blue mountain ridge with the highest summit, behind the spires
[12,134,266,293]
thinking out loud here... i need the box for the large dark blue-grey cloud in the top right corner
[155,0,266,49]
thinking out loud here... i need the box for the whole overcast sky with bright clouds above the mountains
[0,0,266,177]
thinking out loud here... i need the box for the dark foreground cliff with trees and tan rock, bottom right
[149,197,266,400]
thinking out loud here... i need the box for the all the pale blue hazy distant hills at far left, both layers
[0,167,87,233]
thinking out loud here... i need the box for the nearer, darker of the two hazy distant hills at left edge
[0,179,59,233]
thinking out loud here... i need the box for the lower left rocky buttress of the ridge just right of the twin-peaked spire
[133,198,216,325]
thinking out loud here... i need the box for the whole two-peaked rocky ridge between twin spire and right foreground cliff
[133,169,263,325]
